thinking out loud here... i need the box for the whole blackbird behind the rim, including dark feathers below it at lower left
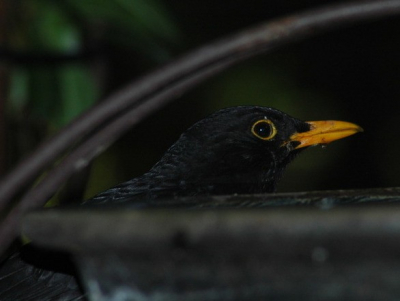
[0,106,362,300]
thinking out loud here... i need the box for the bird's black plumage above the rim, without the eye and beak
[86,106,310,204]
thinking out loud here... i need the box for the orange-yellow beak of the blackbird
[290,120,363,149]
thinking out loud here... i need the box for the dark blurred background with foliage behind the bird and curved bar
[0,0,400,200]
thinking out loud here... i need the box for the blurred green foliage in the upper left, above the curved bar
[8,0,179,129]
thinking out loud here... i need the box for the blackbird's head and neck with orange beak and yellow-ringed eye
[145,106,361,195]
